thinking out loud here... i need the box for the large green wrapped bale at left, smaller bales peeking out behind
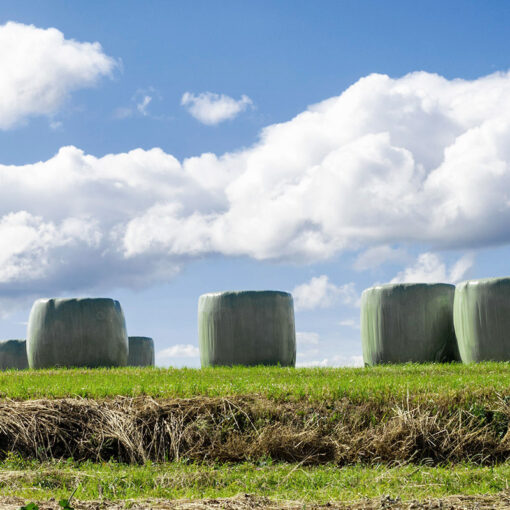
[27,298,128,368]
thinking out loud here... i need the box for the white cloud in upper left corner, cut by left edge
[0,22,116,129]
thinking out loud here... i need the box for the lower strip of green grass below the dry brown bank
[0,458,510,503]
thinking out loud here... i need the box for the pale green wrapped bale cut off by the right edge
[454,278,510,363]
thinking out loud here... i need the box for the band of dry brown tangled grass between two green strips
[0,397,510,465]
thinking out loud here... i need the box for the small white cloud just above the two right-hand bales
[391,252,475,283]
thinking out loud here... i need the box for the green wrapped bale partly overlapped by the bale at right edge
[361,283,459,365]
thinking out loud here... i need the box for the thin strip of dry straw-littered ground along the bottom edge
[0,493,510,510]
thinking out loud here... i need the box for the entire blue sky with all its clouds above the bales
[0,0,510,366]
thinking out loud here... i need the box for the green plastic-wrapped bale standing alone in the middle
[198,291,296,367]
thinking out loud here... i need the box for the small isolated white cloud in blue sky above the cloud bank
[181,92,253,126]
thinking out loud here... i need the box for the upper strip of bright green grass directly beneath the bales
[0,363,510,403]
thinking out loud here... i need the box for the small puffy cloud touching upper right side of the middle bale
[292,275,357,310]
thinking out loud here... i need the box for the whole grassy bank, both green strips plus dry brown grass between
[0,363,510,503]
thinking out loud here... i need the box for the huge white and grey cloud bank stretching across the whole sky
[0,71,510,306]
